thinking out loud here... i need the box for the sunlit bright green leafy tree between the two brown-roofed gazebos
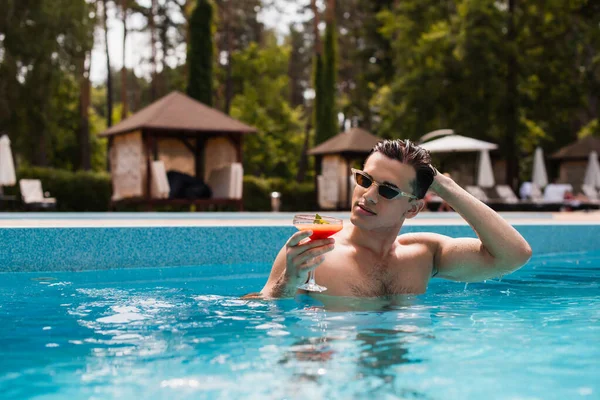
[231,37,304,179]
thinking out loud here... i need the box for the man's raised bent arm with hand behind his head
[431,174,531,282]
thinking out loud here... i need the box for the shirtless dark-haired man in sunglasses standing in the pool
[253,140,531,298]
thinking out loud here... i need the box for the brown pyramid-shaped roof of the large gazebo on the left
[100,91,256,136]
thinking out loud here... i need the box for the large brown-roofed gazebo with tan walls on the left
[100,92,256,210]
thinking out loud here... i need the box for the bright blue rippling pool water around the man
[0,252,600,400]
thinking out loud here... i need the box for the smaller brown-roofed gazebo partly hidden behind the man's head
[308,128,383,209]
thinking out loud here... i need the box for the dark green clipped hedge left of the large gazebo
[17,167,112,211]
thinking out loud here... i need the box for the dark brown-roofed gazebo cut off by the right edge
[550,136,600,187]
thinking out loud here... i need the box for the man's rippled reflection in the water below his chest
[278,296,433,399]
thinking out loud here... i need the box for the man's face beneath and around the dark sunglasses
[350,153,418,229]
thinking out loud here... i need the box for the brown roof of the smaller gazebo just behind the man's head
[308,128,383,156]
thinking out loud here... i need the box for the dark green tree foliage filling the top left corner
[0,0,95,167]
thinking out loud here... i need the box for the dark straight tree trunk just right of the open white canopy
[505,0,519,190]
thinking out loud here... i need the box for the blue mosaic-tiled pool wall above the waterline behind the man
[0,225,600,272]
